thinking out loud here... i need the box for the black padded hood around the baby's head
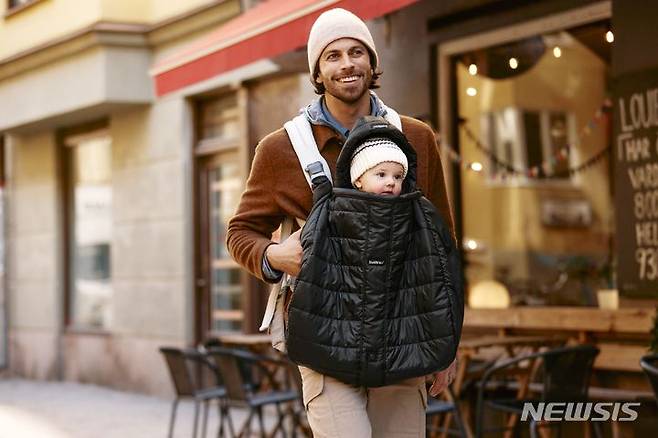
[334,116,416,193]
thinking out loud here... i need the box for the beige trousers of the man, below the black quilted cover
[299,366,427,438]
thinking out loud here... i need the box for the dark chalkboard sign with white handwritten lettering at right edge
[613,70,658,298]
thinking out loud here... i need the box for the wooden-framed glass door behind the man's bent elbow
[194,93,249,341]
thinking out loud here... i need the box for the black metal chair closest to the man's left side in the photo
[207,347,303,437]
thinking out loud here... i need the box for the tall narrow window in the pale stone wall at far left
[64,132,112,330]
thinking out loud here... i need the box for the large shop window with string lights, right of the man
[450,21,615,306]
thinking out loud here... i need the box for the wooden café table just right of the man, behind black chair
[441,336,566,438]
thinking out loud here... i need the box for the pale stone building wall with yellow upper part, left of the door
[0,0,241,393]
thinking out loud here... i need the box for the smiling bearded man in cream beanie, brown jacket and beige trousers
[227,9,455,437]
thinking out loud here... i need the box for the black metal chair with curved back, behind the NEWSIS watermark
[475,345,600,438]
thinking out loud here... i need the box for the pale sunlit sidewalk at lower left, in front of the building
[0,379,266,438]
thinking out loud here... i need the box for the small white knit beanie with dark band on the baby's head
[350,137,409,185]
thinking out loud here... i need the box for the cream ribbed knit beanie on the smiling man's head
[306,8,379,75]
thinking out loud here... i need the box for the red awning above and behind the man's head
[151,0,418,96]
